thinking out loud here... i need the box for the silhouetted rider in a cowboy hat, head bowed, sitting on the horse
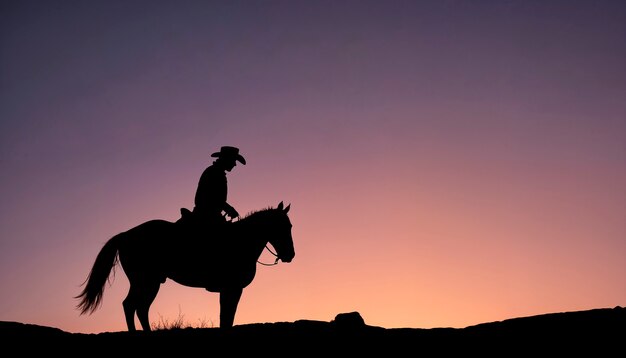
[193,146,246,227]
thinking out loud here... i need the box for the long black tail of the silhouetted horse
[74,234,122,315]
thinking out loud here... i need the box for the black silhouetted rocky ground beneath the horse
[0,306,626,357]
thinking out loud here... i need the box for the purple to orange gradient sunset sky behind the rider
[0,0,626,333]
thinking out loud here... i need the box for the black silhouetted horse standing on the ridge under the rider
[75,201,295,331]
